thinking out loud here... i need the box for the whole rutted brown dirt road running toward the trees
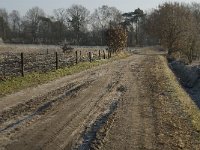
[0,49,200,150]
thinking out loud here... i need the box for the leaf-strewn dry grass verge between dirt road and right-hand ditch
[144,55,200,149]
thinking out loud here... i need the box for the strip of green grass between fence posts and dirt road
[0,53,129,97]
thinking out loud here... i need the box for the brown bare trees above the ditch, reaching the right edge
[145,2,200,63]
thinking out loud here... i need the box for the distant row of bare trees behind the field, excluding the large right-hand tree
[0,5,144,45]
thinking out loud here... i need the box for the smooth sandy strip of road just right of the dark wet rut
[97,57,156,150]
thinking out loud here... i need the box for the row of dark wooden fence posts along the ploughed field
[0,50,111,81]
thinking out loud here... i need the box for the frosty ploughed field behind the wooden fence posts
[0,44,107,81]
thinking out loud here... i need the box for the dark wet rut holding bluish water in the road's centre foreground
[74,100,118,150]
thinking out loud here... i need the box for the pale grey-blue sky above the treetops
[0,0,200,15]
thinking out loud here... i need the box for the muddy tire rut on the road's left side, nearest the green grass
[0,65,109,126]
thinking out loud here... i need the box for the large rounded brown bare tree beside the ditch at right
[147,3,197,62]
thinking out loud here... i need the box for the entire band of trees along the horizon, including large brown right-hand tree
[0,2,200,62]
